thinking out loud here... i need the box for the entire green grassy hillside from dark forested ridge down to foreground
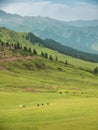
[0,26,98,130]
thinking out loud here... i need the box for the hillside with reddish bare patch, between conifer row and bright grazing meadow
[0,33,98,92]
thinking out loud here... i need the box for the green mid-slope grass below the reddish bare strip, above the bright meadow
[0,58,98,91]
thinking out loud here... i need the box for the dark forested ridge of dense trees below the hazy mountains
[26,32,98,62]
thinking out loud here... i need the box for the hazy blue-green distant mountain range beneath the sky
[0,11,98,54]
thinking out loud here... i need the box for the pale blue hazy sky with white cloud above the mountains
[0,0,98,21]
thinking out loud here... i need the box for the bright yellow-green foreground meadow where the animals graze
[0,91,98,130]
